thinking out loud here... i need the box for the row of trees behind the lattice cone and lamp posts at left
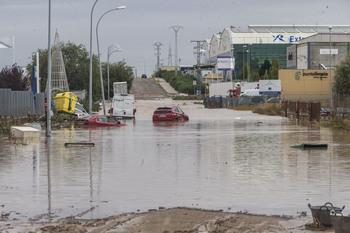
[0,42,134,101]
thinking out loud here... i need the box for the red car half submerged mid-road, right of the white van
[153,107,189,121]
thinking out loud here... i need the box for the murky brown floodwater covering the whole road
[0,100,350,220]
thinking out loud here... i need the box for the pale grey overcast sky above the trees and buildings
[0,0,350,76]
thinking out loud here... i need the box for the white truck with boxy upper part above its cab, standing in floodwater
[110,82,136,118]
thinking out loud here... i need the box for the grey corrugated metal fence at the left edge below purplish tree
[0,89,45,117]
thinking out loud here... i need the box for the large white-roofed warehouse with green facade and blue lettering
[202,25,350,81]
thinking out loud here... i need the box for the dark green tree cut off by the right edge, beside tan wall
[334,55,350,95]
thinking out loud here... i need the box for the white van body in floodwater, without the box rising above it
[110,94,136,118]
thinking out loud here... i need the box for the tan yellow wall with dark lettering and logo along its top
[279,69,334,102]
